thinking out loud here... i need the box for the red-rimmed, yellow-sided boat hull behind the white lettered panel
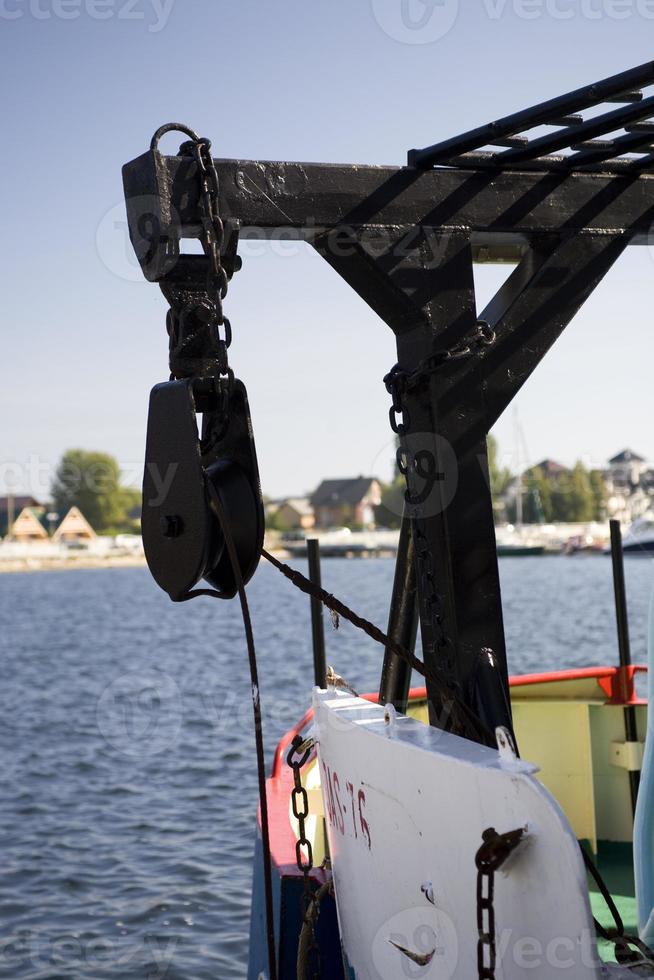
[248,666,646,980]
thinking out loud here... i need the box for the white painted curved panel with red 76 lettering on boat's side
[314,691,652,980]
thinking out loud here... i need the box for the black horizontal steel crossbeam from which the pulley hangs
[123,151,654,254]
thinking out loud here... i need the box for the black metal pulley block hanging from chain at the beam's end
[141,377,264,601]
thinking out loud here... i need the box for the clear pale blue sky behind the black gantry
[0,0,654,495]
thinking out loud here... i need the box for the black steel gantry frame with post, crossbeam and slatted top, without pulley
[124,63,654,744]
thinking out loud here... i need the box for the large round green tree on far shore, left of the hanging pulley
[51,449,140,531]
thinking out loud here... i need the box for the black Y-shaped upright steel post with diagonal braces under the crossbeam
[316,229,627,730]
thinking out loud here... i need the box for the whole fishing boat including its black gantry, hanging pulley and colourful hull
[123,63,654,980]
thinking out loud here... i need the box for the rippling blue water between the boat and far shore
[0,557,654,980]
